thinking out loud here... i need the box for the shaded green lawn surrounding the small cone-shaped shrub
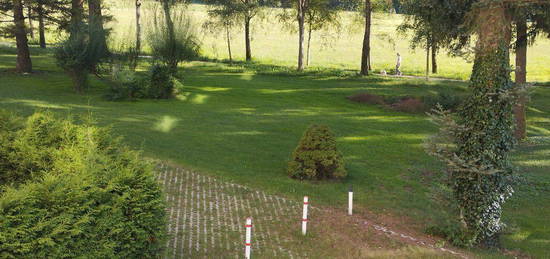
[0,46,550,258]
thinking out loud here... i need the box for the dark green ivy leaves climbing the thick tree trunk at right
[428,44,515,246]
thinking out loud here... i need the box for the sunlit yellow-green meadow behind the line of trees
[102,0,550,82]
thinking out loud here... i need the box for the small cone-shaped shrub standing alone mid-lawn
[287,125,347,180]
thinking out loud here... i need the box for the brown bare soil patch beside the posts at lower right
[314,208,473,258]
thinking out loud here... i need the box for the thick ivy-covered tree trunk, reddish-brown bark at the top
[452,0,514,246]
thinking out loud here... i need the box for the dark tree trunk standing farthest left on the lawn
[13,0,32,73]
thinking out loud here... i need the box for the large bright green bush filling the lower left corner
[0,112,166,258]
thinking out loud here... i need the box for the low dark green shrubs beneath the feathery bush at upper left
[107,64,183,101]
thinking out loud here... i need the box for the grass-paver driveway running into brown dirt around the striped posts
[157,165,466,258]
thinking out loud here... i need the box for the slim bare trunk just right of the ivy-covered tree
[514,17,527,140]
